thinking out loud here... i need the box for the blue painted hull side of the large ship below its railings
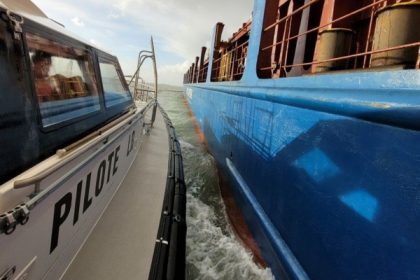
[186,70,420,279]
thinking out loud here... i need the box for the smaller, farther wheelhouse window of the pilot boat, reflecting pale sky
[99,60,131,107]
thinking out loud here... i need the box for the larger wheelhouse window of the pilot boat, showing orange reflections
[26,33,100,127]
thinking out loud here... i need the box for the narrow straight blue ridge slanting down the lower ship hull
[226,158,309,280]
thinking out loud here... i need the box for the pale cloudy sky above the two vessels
[32,0,253,85]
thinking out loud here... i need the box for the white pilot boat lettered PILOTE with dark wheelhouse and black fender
[0,0,186,280]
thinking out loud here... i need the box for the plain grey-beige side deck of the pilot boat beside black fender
[62,110,169,280]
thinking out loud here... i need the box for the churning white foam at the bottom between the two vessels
[187,191,274,279]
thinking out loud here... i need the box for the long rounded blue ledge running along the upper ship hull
[188,85,420,130]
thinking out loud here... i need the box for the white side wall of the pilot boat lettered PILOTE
[0,109,144,279]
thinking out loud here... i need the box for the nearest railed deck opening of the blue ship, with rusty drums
[258,0,420,78]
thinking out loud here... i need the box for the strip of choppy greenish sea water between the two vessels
[158,87,273,280]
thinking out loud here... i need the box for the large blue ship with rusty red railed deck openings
[184,0,420,279]
